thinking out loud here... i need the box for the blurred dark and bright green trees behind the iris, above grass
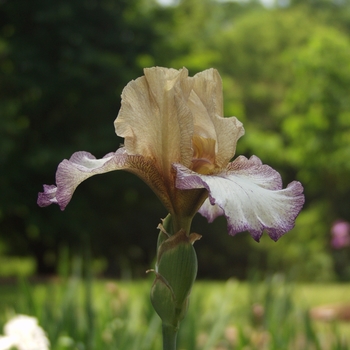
[0,0,350,281]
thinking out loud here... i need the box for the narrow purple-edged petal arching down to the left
[37,148,128,210]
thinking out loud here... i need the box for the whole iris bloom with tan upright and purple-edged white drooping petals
[38,67,304,241]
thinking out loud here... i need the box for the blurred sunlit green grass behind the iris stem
[0,276,350,350]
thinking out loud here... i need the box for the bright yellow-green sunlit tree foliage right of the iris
[212,8,350,278]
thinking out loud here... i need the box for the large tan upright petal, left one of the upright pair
[115,67,193,175]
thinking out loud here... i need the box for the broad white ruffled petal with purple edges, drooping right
[174,156,304,241]
